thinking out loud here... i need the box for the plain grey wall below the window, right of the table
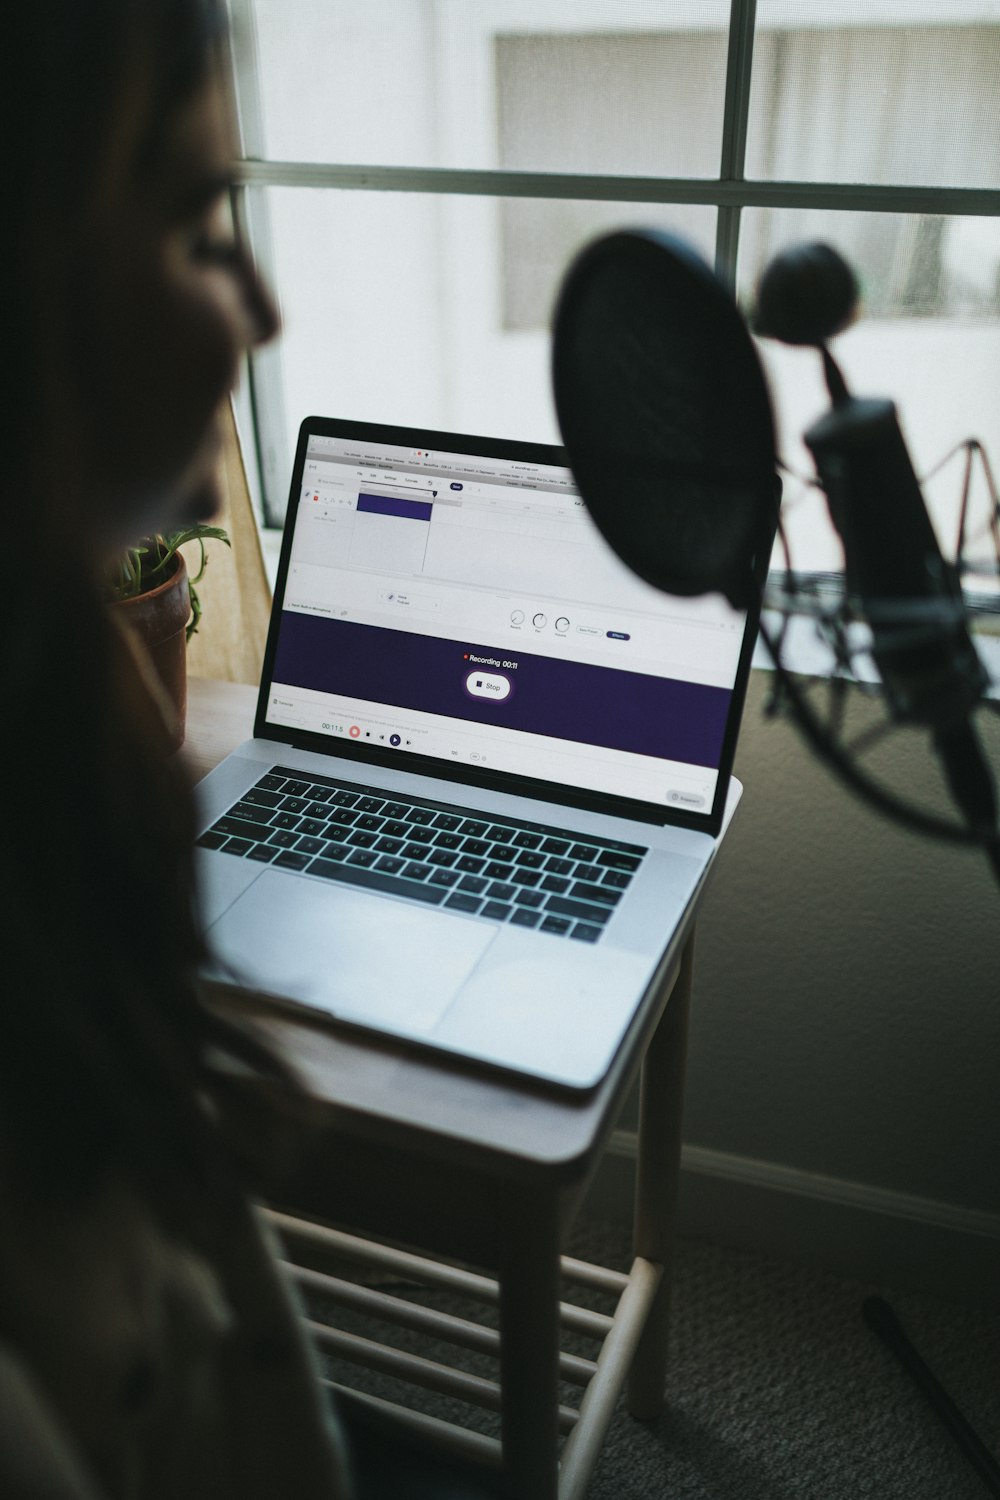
[598,671,1000,1296]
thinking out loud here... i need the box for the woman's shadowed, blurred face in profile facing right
[75,60,277,548]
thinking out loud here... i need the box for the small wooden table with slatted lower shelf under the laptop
[183,678,728,1500]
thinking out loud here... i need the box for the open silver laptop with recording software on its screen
[196,417,756,1091]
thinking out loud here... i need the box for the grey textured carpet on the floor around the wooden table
[307,1223,1000,1500]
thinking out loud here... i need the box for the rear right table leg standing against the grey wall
[628,933,694,1422]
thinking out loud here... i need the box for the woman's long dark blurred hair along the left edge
[0,0,302,1194]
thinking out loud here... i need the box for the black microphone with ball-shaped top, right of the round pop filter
[757,245,1000,867]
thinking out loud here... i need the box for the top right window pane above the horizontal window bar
[747,0,1000,188]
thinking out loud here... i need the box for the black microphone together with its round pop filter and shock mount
[553,230,1000,876]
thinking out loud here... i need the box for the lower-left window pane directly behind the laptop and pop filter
[250,188,715,519]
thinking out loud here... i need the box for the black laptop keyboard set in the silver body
[198,765,648,944]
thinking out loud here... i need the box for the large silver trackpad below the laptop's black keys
[208,870,495,1035]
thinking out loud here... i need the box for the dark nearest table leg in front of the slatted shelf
[499,1194,559,1500]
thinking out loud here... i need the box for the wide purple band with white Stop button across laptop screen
[273,611,732,768]
